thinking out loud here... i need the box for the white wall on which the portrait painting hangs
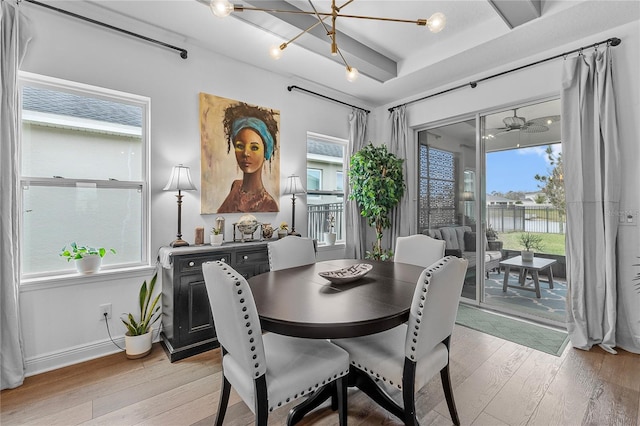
[20,4,356,374]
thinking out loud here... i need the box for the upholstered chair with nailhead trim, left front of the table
[202,261,349,426]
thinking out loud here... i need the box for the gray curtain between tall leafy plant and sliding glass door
[389,105,411,250]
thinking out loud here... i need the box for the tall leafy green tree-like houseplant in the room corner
[349,142,405,260]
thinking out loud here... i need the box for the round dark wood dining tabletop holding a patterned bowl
[248,259,424,339]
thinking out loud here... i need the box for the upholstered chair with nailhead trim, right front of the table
[332,256,468,425]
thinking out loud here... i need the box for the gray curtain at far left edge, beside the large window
[0,0,30,389]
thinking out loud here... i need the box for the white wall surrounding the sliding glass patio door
[373,22,640,352]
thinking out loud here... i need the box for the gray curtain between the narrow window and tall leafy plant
[344,108,368,259]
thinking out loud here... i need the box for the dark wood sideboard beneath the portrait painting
[158,241,269,362]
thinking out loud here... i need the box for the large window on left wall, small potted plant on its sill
[20,73,149,278]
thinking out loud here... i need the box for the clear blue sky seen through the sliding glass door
[486,144,561,194]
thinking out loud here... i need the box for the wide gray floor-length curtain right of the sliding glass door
[561,46,631,353]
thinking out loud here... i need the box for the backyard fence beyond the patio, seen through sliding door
[487,205,566,234]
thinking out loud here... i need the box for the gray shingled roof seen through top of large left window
[22,86,142,127]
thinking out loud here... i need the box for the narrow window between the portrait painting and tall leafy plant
[307,133,347,244]
